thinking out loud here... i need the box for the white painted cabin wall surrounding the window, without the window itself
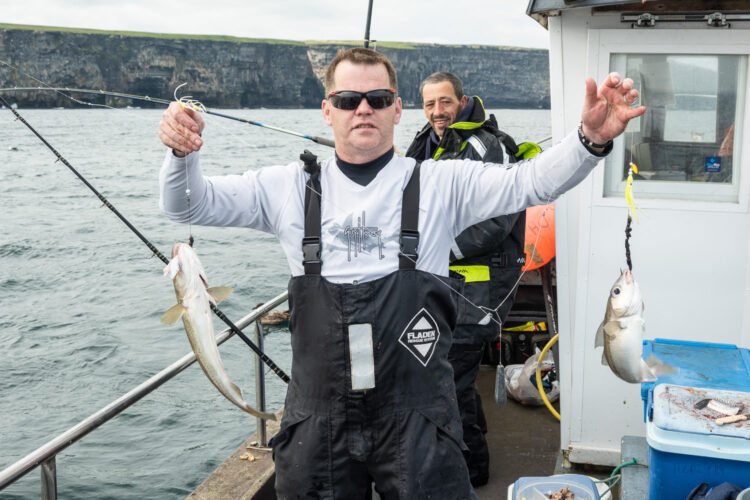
[549,8,750,465]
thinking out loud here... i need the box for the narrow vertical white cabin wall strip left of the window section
[549,5,619,463]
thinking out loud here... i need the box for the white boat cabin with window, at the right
[527,0,750,466]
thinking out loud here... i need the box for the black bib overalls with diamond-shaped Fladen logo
[272,158,476,500]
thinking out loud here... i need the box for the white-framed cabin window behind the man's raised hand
[604,53,747,202]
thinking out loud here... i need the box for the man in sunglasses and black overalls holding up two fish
[159,48,645,500]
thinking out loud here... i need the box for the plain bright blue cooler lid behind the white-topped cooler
[641,339,750,400]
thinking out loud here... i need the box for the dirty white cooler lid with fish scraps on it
[653,384,750,439]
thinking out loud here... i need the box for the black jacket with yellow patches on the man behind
[406,97,538,344]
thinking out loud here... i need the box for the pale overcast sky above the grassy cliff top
[0,0,548,48]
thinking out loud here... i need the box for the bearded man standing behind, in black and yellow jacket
[406,71,538,486]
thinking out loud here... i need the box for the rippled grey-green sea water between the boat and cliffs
[0,109,550,499]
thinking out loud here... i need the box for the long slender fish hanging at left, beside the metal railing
[161,243,276,420]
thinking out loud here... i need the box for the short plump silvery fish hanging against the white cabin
[594,270,676,384]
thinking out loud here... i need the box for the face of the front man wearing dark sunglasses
[323,61,401,163]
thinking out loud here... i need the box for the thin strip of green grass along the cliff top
[0,23,546,50]
